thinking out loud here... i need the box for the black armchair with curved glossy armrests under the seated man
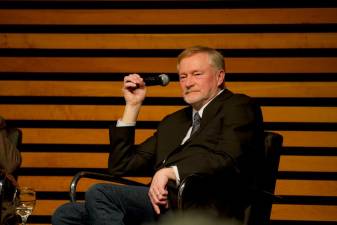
[70,132,283,225]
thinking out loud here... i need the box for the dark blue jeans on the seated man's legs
[52,184,157,225]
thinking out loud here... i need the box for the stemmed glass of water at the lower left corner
[14,187,36,225]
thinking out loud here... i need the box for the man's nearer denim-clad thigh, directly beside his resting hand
[85,184,156,225]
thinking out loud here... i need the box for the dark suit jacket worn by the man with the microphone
[109,89,264,216]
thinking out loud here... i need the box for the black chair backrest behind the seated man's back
[246,131,283,225]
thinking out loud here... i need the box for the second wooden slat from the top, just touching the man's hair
[0,33,337,49]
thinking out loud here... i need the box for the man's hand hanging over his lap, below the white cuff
[148,168,176,214]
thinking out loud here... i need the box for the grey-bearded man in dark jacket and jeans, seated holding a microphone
[53,46,263,225]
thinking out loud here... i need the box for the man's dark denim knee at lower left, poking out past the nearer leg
[52,203,88,225]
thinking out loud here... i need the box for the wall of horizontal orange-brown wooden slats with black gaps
[0,0,337,225]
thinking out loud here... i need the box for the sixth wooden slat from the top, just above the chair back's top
[22,128,337,148]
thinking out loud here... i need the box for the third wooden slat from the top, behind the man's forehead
[0,57,337,73]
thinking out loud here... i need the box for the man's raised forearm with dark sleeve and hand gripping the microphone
[108,74,155,175]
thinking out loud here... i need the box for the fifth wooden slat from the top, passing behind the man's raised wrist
[0,104,337,122]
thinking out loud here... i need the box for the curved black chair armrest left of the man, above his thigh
[69,171,145,202]
